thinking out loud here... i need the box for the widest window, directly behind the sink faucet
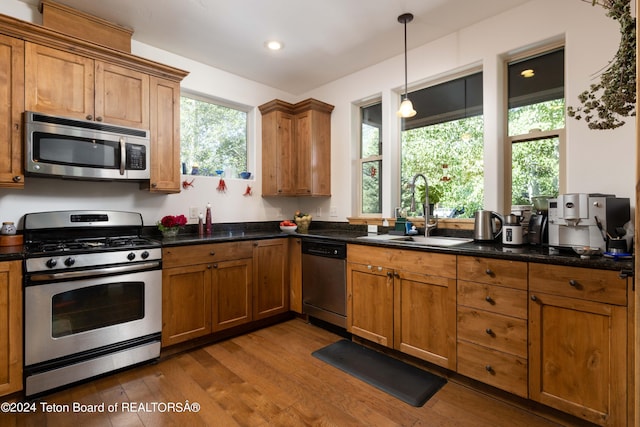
[401,72,484,218]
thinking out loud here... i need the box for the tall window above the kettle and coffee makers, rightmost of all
[506,49,565,205]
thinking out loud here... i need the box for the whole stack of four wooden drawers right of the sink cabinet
[457,256,528,397]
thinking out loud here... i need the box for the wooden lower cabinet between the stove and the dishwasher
[162,239,289,347]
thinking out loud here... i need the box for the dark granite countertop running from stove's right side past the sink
[156,222,634,272]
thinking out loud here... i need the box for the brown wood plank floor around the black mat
[0,319,588,427]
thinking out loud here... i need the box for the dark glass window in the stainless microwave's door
[33,132,120,169]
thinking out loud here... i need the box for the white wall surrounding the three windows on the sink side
[305,0,636,221]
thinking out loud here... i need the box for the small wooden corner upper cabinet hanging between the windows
[258,99,333,196]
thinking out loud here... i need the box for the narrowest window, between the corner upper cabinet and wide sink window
[359,102,382,215]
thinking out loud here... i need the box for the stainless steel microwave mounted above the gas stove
[24,111,150,181]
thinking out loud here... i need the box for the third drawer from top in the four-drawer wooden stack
[458,307,527,359]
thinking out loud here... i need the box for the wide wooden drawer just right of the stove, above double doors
[162,240,253,268]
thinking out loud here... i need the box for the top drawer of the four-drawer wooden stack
[458,256,527,290]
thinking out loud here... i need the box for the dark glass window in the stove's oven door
[51,282,144,338]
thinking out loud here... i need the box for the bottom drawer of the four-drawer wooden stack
[458,341,527,397]
